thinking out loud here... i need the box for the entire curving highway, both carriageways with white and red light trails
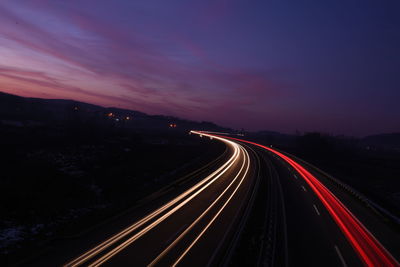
[36,131,400,267]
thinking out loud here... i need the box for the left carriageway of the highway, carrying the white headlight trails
[60,133,257,266]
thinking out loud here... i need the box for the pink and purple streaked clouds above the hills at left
[0,1,294,132]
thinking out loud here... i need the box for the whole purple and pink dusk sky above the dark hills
[0,0,400,136]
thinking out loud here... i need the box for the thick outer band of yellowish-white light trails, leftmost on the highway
[65,133,243,267]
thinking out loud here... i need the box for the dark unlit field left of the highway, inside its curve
[0,124,224,264]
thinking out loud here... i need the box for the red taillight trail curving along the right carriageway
[209,135,400,267]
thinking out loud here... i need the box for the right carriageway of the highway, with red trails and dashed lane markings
[205,133,400,266]
